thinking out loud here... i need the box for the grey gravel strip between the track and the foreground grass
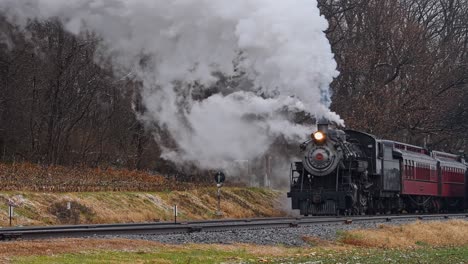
[106,217,466,246]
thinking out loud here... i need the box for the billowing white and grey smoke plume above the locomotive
[0,0,342,168]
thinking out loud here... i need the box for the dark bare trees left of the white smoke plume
[0,21,164,169]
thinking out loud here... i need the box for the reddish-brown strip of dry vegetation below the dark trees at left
[0,163,193,192]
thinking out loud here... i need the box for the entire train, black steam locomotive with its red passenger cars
[288,121,468,216]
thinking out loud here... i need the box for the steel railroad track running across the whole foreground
[0,214,468,240]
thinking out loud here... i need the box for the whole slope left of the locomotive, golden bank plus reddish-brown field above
[0,163,284,226]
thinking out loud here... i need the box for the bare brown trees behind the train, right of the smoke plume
[319,0,468,151]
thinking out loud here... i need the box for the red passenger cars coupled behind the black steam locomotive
[380,140,468,211]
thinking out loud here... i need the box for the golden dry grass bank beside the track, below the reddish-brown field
[0,187,283,226]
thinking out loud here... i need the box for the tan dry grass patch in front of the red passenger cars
[341,220,468,248]
